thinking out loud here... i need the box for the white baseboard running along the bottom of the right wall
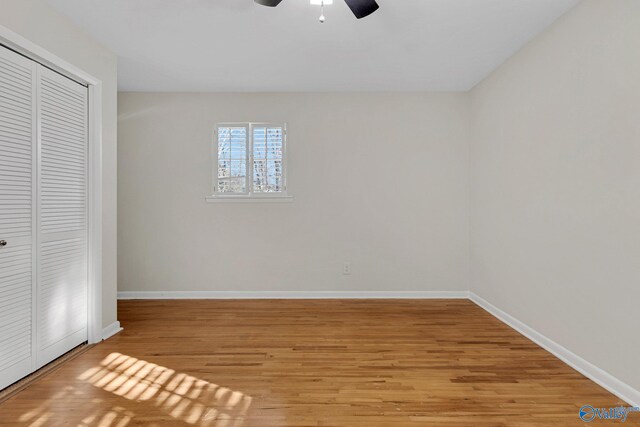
[469,292,640,406]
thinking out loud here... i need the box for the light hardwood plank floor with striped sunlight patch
[0,300,640,427]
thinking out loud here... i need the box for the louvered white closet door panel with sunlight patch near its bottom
[37,67,88,366]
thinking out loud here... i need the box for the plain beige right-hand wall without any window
[471,0,640,390]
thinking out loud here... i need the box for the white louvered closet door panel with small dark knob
[0,46,36,389]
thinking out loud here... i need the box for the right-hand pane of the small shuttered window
[253,127,284,193]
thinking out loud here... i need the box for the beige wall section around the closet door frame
[0,0,117,326]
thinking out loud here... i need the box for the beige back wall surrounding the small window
[118,93,468,291]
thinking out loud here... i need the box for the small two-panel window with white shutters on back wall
[208,123,287,199]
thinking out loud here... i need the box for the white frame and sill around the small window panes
[206,122,293,203]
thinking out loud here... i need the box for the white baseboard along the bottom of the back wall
[118,291,469,300]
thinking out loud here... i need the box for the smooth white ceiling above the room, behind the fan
[45,0,579,91]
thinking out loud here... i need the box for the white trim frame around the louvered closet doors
[0,25,103,344]
